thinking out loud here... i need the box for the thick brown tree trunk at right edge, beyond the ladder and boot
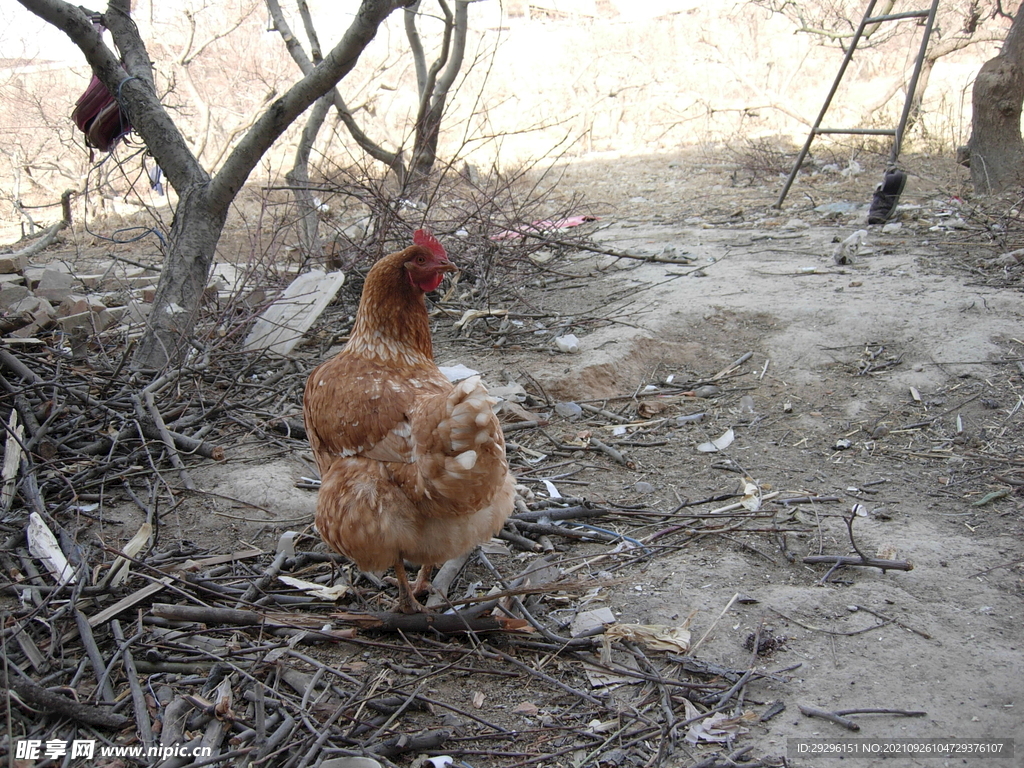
[969,3,1024,195]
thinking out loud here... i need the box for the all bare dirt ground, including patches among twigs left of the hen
[8,151,1024,768]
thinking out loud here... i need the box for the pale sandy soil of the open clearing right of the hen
[495,151,1024,766]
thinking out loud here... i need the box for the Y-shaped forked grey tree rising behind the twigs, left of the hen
[18,0,411,370]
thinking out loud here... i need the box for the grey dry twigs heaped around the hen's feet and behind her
[0,348,802,767]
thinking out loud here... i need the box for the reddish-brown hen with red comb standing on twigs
[303,229,514,612]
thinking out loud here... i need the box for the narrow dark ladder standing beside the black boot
[775,0,939,208]
